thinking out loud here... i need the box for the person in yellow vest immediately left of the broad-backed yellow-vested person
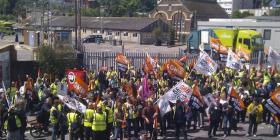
[84,103,95,140]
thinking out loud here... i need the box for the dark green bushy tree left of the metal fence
[38,46,77,77]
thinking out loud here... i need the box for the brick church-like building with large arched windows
[149,0,228,34]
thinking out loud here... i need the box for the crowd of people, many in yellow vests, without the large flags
[0,63,280,140]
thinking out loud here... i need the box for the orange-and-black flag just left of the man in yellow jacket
[229,87,245,111]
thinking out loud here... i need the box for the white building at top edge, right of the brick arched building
[217,0,254,15]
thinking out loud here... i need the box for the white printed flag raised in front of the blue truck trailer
[194,51,218,76]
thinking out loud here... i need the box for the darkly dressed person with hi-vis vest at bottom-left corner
[5,106,21,140]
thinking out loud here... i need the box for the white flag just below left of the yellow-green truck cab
[226,50,241,70]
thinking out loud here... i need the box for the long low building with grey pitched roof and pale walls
[24,16,169,46]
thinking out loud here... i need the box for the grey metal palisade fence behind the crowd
[83,49,265,71]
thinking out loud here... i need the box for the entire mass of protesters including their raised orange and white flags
[0,47,280,140]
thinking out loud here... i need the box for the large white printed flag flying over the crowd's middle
[164,81,192,103]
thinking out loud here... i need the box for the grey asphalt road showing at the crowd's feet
[17,120,280,140]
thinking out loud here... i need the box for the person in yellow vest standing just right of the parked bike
[50,99,59,140]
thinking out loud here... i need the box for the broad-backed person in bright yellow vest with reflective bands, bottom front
[92,105,106,140]
